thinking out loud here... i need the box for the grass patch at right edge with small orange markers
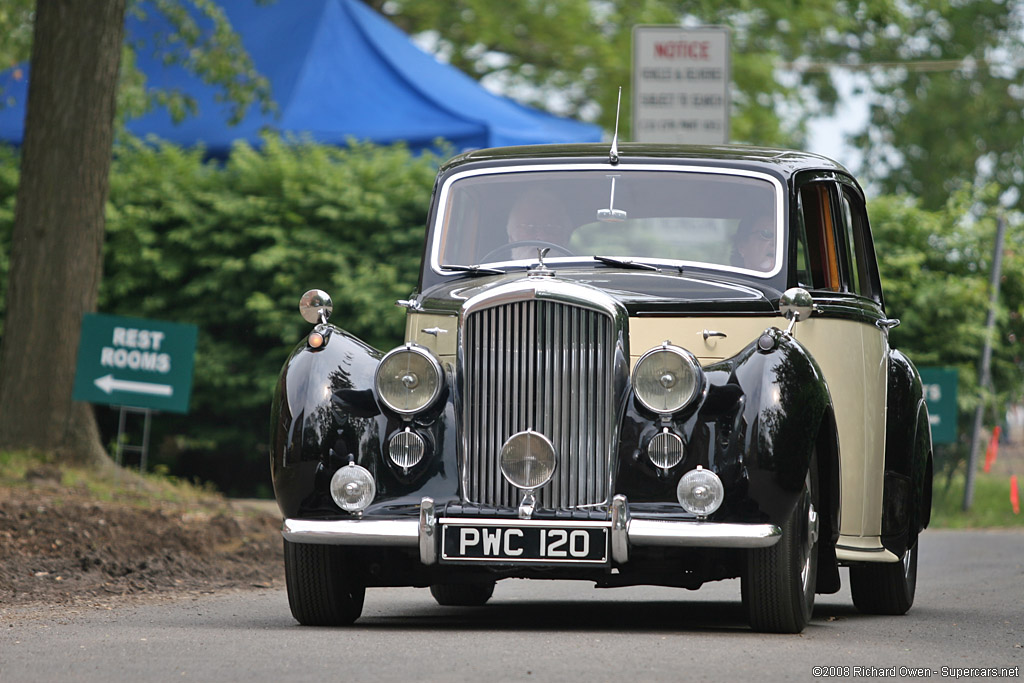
[931,472,1024,528]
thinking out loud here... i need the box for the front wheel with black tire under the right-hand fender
[740,460,818,633]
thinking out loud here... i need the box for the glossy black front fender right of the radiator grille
[616,328,839,533]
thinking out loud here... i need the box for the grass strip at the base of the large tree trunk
[0,451,223,507]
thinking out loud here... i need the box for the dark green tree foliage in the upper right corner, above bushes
[854,0,1024,210]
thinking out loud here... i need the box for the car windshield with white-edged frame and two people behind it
[432,166,782,278]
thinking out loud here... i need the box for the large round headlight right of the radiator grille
[633,344,703,414]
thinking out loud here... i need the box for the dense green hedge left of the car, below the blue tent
[0,137,437,495]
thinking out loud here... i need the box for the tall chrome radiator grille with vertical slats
[462,299,614,509]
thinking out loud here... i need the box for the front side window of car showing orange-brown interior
[797,182,842,292]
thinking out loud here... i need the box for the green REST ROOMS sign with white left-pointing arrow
[73,313,198,413]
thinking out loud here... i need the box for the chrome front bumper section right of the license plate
[628,517,782,548]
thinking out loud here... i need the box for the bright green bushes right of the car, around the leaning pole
[870,185,1024,470]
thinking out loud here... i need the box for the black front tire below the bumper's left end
[285,541,367,626]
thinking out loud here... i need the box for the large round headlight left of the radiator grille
[376,344,442,415]
